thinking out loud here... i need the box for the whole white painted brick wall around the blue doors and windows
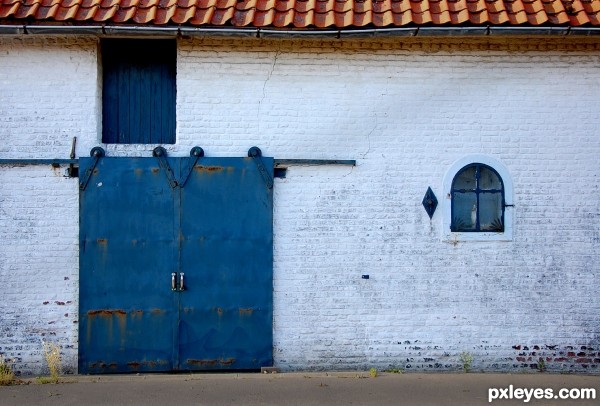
[0,39,600,373]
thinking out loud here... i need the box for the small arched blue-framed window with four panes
[450,163,506,232]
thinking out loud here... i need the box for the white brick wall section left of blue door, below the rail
[0,166,79,374]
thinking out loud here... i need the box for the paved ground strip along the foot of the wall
[0,372,600,406]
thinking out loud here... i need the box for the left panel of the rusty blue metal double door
[79,158,178,373]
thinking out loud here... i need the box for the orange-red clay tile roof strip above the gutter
[0,0,600,28]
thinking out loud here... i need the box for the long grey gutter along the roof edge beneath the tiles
[0,24,600,39]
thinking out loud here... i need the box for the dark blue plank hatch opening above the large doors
[100,39,177,144]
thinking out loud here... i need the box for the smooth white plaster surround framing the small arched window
[441,154,514,242]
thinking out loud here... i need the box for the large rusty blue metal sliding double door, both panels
[79,154,273,373]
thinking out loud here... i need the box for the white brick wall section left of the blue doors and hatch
[0,38,98,374]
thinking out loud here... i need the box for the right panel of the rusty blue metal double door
[179,158,273,370]
